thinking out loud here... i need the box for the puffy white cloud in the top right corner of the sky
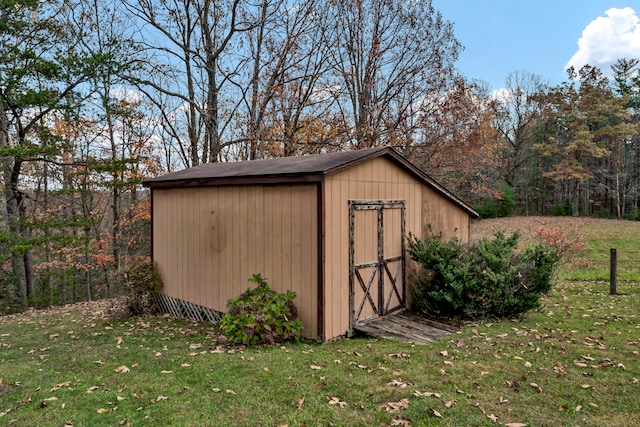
[565,7,640,75]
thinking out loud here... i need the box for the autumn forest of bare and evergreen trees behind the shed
[0,0,640,313]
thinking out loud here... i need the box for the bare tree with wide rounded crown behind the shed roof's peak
[332,0,461,148]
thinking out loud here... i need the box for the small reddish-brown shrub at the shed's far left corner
[117,257,162,316]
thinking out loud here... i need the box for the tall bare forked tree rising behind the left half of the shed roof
[125,0,253,166]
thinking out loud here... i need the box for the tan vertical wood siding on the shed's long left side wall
[153,184,318,338]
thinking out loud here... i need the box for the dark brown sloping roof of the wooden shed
[143,147,478,217]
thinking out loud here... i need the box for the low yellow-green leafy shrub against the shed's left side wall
[220,274,303,345]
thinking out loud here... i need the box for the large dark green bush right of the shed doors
[409,232,560,319]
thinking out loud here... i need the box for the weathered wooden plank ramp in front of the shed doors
[354,311,459,344]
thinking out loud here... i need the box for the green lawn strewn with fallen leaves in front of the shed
[0,219,640,427]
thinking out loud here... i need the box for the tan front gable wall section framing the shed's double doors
[323,157,423,339]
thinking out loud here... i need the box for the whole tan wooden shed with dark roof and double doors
[145,147,477,340]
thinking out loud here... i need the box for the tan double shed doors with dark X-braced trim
[349,200,405,327]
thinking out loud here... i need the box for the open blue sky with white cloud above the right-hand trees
[432,0,640,90]
